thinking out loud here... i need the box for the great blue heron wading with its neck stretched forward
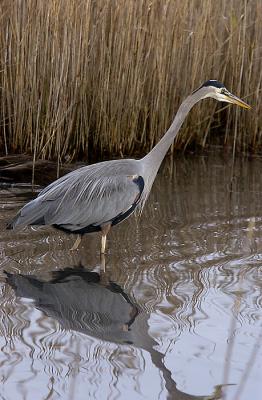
[7,80,250,254]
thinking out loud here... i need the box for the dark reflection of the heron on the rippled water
[6,266,221,400]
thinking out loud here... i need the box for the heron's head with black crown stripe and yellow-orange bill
[193,80,251,109]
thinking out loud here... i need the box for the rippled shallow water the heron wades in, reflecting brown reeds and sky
[0,155,262,400]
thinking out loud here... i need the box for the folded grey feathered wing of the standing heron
[10,160,141,232]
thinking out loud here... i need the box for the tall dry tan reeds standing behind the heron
[0,0,262,162]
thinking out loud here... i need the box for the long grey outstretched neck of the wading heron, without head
[142,92,202,168]
